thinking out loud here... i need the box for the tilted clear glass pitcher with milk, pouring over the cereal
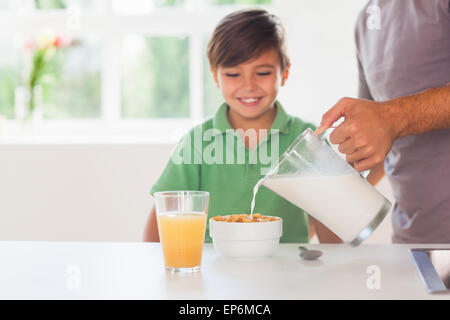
[259,129,391,246]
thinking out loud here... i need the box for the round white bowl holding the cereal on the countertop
[209,218,283,259]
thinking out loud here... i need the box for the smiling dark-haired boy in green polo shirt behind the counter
[144,10,340,243]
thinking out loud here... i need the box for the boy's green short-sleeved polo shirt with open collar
[150,102,315,243]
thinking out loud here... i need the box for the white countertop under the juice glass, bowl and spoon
[0,241,450,300]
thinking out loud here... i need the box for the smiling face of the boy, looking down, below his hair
[211,49,289,120]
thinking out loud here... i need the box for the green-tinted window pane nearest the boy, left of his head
[121,35,189,118]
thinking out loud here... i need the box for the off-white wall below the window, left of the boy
[0,144,172,241]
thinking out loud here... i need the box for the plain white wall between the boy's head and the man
[274,0,365,124]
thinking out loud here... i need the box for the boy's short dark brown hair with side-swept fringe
[207,9,290,70]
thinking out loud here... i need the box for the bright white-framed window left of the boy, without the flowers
[0,0,272,139]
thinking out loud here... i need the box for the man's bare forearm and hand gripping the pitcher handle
[316,83,450,171]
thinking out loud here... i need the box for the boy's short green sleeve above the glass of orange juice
[150,130,200,195]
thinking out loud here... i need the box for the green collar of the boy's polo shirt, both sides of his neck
[213,101,291,133]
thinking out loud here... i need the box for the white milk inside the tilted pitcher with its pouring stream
[251,173,385,242]
